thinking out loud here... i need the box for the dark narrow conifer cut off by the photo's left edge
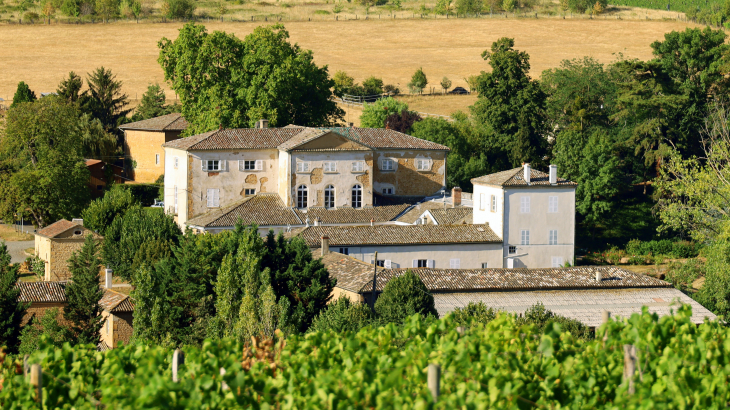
[0,241,28,352]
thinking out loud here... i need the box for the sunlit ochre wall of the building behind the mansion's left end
[124,130,180,183]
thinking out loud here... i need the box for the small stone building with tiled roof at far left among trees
[35,219,104,281]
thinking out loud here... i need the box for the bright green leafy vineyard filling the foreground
[0,307,730,409]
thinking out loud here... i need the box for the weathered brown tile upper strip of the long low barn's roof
[362,268,672,292]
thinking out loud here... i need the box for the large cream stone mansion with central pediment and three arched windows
[162,120,449,231]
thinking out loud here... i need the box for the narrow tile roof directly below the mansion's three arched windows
[294,204,408,224]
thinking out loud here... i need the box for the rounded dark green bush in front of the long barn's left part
[375,270,438,323]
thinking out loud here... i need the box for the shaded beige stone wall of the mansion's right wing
[373,150,446,196]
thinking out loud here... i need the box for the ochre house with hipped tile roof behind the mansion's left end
[119,114,188,183]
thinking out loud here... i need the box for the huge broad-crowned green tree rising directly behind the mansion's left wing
[158,24,343,135]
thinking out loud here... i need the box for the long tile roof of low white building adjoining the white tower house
[290,225,502,248]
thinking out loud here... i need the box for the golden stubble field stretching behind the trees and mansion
[0,18,687,114]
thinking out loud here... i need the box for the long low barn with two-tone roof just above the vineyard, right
[322,252,717,328]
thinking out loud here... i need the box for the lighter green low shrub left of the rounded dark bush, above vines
[309,296,373,334]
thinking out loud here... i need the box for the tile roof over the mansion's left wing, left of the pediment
[162,127,306,150]
